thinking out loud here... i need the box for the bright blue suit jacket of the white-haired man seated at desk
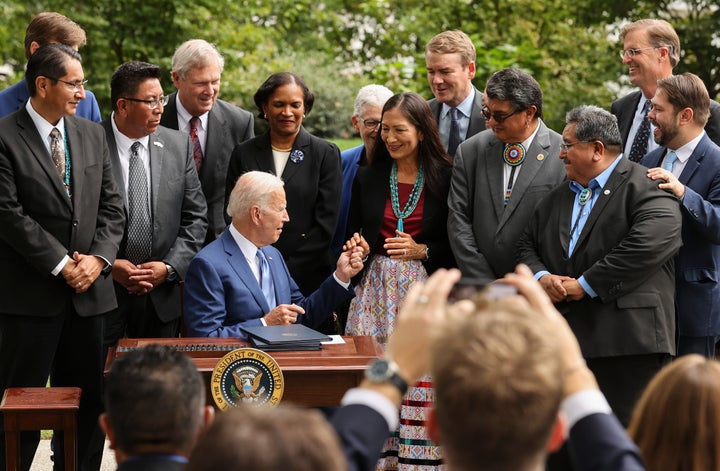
[185,230,355,338]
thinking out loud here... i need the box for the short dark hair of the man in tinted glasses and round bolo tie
[485,68,542,118]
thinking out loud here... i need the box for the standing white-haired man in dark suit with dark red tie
[160,39,255,245]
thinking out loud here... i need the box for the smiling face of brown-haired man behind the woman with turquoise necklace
[425,52,475,107]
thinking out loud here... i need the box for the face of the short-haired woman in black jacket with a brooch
[262,83,305,137]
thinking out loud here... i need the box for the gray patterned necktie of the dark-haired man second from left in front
[125,142,152,265]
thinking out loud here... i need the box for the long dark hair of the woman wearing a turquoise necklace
[372,92,452,199]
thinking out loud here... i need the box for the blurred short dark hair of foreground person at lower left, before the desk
[105,345,205,455]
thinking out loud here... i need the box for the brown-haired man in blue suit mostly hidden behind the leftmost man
[0,11,101,122]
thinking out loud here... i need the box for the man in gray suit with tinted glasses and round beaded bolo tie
[448,69,565,283]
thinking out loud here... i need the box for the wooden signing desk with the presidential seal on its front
[105,336,382,407]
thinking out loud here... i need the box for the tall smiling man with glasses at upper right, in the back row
[610,19,720,162]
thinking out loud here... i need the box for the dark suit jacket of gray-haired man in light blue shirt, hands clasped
[518,159,682,358]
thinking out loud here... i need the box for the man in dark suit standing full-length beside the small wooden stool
[0,44,125,471]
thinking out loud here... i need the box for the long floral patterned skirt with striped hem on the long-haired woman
[345,255,444,471]
